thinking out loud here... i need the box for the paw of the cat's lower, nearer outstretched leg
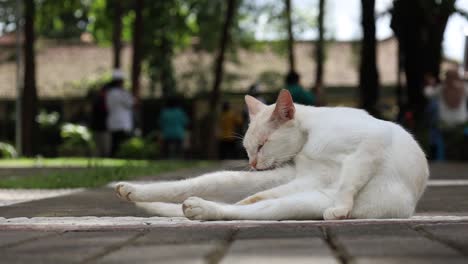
[182,197,221,220]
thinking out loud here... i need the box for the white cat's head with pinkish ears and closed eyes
[244,90,306,170]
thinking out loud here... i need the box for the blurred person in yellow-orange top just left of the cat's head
[219,102,242,159]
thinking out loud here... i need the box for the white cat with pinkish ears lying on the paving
[116,90,429,220]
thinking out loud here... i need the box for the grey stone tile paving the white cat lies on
[0,164,468,264]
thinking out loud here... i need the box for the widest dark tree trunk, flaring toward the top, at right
[391,0,455,127]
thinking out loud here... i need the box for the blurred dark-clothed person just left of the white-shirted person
[90,83,111,157]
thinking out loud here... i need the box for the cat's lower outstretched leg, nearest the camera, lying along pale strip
[183,191,333,220]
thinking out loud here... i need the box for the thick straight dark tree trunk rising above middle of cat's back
[359,0,379,115]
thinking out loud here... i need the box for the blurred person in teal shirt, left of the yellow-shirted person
[159,96,189,159]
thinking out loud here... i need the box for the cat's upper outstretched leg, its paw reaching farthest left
[115,167,295,203]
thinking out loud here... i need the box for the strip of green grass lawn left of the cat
[0,158,213,189]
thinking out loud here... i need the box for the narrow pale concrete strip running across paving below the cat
[0,216,468,231]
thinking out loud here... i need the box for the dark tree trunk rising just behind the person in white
[132,0,143,98]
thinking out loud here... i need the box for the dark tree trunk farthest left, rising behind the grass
[21,0,37,156]
